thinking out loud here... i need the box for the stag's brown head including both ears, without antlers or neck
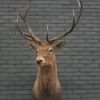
[29,42,62,66]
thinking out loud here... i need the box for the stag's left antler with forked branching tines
[17,0,41,44]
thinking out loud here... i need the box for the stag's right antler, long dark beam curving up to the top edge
[49,0,82,43]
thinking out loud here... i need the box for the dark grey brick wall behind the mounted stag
[0,0,100,100]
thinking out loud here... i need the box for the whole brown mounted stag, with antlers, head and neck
[17,0,82,100]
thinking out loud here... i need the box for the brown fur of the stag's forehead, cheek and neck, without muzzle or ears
[32,43,61,100]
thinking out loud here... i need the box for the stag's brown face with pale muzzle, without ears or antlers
[36,42,55,66]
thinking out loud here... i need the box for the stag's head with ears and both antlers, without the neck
[17,0,82,67]
